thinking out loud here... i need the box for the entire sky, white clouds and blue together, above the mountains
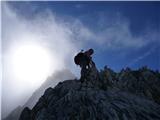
[1,1,160,118]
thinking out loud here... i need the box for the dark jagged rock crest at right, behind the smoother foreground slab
[100,67,160,104]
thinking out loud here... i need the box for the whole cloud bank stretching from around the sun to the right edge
[2,2,158,118]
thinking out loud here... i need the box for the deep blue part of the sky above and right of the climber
[4,1,160,70]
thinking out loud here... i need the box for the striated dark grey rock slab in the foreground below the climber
[20,80,160,120]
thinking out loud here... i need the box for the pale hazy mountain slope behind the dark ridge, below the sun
[3,69,75,120]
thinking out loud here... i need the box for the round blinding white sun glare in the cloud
[12,45,51,87]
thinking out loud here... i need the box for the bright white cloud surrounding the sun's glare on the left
[2,3,82,117]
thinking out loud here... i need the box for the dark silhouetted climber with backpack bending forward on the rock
[74,49,95,82]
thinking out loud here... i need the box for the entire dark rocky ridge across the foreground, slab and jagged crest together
[19,68,160,120]
